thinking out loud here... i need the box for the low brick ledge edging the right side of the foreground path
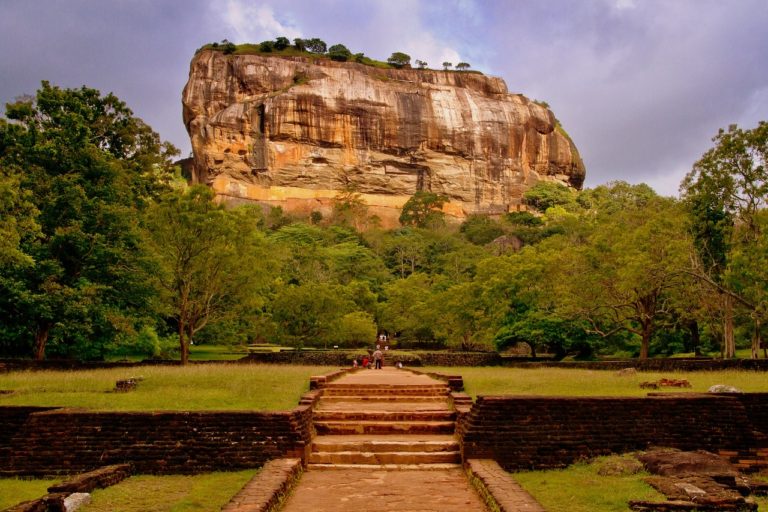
[464,459,546,512]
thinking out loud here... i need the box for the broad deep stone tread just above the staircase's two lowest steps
[312,435,459,453]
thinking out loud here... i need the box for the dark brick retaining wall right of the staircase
[457,394,768,470]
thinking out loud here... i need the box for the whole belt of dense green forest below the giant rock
[0,82,768,360]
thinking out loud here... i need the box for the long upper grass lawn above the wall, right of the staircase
[424,367,768,398]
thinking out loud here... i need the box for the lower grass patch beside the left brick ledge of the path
[80,470,256,512]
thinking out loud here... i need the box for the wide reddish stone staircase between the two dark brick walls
[309,374,461,469]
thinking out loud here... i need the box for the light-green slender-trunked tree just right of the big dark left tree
[144,186,274,364]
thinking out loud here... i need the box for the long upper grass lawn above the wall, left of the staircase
[0,364,337,411]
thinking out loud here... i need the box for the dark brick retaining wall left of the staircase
[0,405,312,475]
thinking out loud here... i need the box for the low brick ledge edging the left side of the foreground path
[221,459,302,512]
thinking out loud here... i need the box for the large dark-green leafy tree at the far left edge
[0,82,177,359]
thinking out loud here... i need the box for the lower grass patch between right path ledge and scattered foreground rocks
[512,456,666,512]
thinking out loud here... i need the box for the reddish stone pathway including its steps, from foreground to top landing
[282,367,486,512]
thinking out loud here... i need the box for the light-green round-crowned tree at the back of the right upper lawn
[564,186,690,359]
